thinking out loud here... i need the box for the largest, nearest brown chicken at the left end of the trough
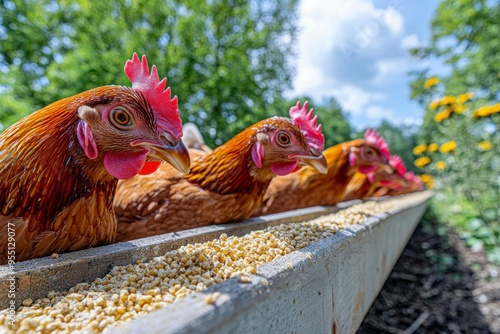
[0,54,190,264]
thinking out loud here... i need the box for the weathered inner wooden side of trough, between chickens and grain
[0,200,352,309]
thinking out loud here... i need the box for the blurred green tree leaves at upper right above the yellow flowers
[412,0,500,103]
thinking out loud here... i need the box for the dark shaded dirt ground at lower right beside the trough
[358,221,500,334]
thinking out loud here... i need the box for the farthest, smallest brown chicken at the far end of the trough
[341,155,410,201]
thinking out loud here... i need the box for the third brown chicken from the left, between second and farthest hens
[253,130,391,216]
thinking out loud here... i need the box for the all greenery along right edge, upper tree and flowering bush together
[411,0,500,261]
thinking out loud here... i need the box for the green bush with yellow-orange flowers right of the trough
[413,78,500,261]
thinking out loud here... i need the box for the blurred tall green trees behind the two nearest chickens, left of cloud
[0,0,297,145]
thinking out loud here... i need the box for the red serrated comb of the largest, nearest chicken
[125,52,182,139]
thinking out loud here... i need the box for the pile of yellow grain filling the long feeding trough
[0,194,425,334]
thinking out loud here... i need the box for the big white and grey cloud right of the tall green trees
[295,0,404,88]
